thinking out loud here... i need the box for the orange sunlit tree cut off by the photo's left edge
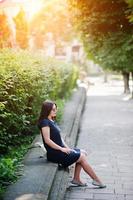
[0,13,11,48]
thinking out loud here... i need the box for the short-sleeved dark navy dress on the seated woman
[39,119,80,167]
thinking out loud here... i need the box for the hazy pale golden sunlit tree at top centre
[30,0,74,48]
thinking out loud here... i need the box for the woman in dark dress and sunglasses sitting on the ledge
[38,101,106,188]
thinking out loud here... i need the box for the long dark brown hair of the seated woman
[38,101,57,123]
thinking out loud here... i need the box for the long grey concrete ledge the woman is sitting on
[4,88,86,200]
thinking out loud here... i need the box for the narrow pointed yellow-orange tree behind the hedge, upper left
[14,8,28,49]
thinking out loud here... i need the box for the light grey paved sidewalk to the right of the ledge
[64,80,133,200]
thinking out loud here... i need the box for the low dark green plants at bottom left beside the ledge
[0,142,33,199]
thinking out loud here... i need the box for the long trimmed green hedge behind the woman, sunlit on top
[0,49,78,154]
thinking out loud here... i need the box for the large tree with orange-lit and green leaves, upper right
[69,0,133,92]
